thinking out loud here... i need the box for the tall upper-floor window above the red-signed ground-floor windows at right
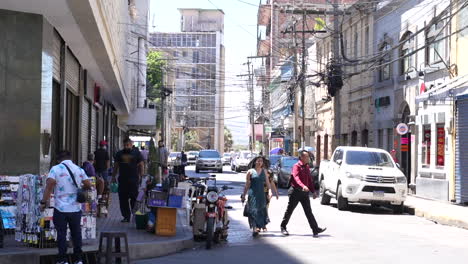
[426,21,446,64]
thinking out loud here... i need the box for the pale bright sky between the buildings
[150,0,260,144]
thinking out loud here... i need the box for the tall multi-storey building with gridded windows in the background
[150,9,225,151]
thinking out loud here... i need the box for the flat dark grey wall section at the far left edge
[0,10,44,175]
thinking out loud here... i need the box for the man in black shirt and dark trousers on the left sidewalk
[112,138,143,223]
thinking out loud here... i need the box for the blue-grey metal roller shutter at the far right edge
[455,98,468,203]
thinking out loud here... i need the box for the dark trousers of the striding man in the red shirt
[281,187,319,234]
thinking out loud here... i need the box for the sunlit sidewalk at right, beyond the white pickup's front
[405,195,468,229]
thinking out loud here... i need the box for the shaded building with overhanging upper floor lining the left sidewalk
[0,0,155,175]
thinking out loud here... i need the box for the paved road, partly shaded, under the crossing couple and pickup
[138,167,468,264]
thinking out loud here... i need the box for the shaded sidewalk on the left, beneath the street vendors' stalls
[0,194,194,264]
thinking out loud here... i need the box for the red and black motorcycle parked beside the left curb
[191,177,233,249]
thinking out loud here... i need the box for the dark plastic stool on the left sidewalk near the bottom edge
[98,232,130,264]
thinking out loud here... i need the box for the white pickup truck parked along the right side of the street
[319,147,408,213]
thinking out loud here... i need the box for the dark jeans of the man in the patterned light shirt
[53,209,83,261]
